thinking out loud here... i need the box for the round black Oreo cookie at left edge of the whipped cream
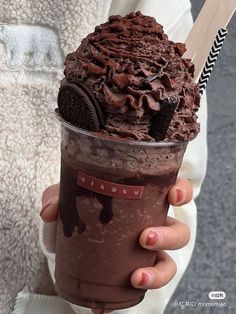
[57,79,105,131]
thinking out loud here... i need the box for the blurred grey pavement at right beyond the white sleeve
[165,0,236,314]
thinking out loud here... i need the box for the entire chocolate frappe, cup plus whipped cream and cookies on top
[55,12,200,310]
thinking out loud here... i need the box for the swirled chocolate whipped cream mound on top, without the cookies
[61,12,200,141]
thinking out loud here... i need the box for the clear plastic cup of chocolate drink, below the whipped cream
[55,122,187,310]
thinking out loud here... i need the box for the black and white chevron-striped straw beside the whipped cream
[198,28,228,94]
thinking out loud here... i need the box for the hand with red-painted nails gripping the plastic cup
[40,179,192,314]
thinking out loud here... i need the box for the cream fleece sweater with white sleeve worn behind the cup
[0,0,207,314]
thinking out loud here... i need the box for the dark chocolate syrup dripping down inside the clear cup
[59,163,176,237]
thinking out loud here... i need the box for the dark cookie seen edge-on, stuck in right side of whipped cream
[149,98,179,141]
